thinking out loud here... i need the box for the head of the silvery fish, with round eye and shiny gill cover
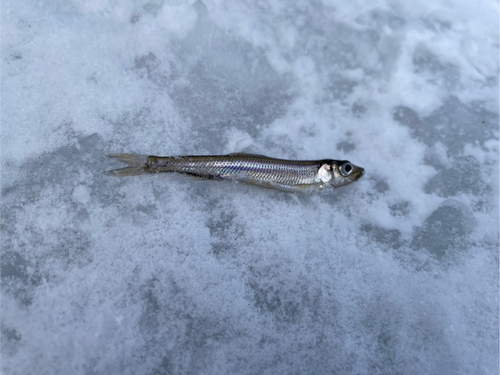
[318,160,365,188]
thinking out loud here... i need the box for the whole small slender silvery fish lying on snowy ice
[104,153,364,192]
